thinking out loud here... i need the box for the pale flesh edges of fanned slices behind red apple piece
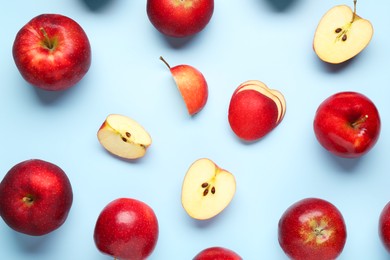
[235,80,286,124]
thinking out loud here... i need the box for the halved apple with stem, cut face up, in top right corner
[313,0,374,64]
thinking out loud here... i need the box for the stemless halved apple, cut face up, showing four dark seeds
[181,158,236,220]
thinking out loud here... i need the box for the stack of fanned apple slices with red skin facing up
[228,80,286,141]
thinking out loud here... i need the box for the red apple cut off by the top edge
[146,0,214,38]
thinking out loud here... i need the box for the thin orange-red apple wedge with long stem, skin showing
[160,57,208,116]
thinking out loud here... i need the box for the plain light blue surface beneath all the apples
[0,0,390,260]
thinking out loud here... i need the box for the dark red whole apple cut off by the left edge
[0,159,73,236]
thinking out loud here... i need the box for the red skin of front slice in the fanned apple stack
[228,90,278,141]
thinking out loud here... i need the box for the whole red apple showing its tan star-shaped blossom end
[278,198,347,260]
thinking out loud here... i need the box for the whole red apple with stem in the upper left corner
[12,14,91,91]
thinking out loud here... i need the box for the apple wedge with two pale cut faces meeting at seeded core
[97,114,152,159]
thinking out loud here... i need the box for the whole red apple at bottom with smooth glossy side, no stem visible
[94,198,159,260]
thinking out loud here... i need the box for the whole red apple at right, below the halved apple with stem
[314,92,381,158]
